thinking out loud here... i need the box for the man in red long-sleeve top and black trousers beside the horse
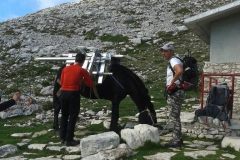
[59,54,93,146]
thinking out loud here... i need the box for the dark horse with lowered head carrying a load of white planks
[53,63,157,132]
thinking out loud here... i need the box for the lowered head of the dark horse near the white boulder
[138,108,157,126]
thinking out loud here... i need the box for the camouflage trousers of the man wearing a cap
[167,89,184,141]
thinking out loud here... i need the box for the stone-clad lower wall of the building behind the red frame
[203,62,240,112]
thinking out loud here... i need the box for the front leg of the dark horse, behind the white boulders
[110,94,126,134]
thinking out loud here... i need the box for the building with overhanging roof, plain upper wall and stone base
[185,1,240,111]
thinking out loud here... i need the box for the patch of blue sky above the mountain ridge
[0,0,79,22]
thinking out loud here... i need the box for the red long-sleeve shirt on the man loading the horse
[60,64,93,91]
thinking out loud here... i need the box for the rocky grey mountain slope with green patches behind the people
[0,0,234,93]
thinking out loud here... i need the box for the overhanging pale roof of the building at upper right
[184,0,240,44]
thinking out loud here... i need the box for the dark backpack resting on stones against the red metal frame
[195,83,233,126]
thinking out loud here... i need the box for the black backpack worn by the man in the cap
[168,51,199,91]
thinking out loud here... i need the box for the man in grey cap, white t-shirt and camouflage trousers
[161,44,184,148]
